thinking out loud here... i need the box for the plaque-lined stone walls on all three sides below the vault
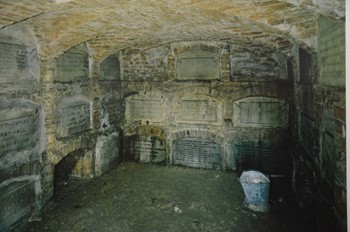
[0,19,346,231]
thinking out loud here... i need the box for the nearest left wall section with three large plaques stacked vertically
[0,25,42,231]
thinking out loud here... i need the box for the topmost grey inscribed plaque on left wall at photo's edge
[0,43,29,79]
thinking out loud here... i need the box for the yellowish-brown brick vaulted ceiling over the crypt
[0,0,345,60]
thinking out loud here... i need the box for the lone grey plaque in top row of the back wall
[175,51,220,80]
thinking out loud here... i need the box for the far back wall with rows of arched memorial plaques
[119,41,291,174]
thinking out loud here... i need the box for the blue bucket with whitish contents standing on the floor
[239,171,270,212]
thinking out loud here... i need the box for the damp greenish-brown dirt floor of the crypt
[24,163,302,232]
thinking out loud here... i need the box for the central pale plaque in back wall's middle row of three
[174,96,222,124]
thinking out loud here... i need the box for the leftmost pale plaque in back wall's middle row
[125,96,165,122]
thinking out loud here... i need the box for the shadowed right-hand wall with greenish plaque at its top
[292,16,347,231]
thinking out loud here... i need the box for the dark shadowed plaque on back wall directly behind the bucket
[234,141,286,173]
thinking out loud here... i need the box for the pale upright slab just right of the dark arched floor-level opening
[95,133,119,175]
